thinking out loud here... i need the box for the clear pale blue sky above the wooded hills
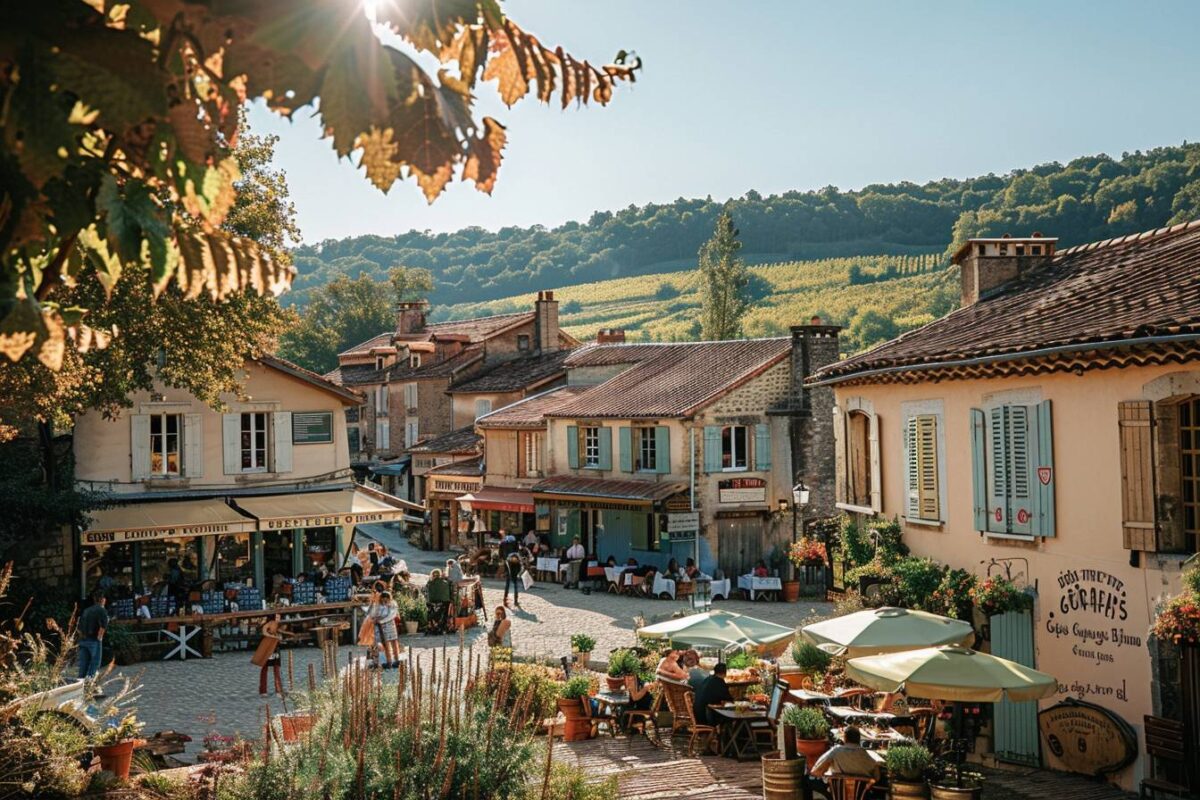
[251,0,1200,242]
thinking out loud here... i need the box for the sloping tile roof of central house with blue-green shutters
[546,337,792,419]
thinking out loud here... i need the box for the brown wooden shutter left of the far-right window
[1117,401,1158,553]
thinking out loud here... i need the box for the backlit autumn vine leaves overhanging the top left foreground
[0,0,641,369]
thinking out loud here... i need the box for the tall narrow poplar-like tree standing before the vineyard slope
[698,209,750,341]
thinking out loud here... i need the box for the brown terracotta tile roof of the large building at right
[810,221,1200,381]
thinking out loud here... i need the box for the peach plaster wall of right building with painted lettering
[836,366,1200,788]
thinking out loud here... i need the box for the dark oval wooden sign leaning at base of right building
[1038,699,1138,775]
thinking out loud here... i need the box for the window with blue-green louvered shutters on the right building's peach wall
[971,401,1055,536]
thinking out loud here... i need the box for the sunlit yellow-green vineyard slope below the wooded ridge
[433,254,958,353]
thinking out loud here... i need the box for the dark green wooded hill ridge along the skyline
[283,144,1200,315]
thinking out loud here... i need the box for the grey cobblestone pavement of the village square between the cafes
[122,527,830,759]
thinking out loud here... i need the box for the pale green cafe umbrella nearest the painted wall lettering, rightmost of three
[846,645,1058,703]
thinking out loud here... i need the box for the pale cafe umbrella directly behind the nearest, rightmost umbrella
[800,607,974,658]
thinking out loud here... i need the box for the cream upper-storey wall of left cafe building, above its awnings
[74,362,349,493]
